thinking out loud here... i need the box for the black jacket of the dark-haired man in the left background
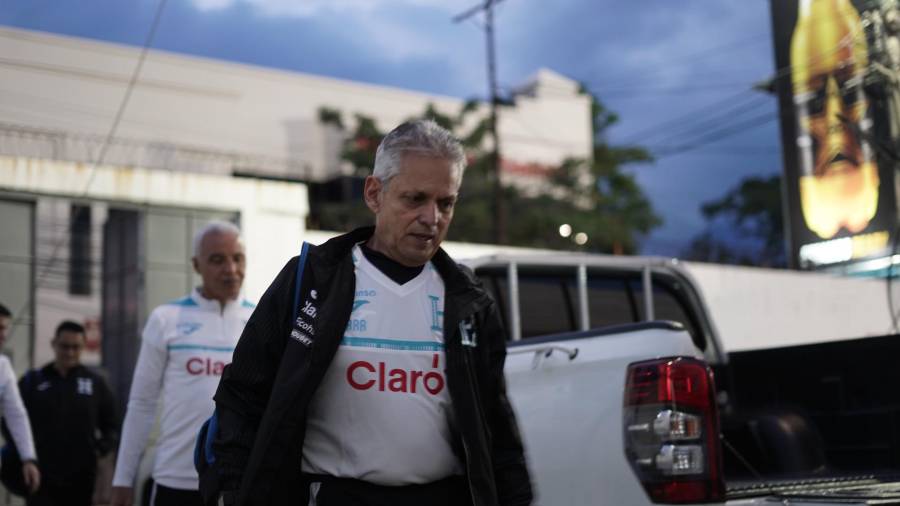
[19,363,119,485]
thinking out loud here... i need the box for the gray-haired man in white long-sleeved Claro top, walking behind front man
[111,221,254,506]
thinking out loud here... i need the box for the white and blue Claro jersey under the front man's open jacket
[302,246,462,486]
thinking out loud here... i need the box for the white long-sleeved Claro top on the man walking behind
[113,290,254,490]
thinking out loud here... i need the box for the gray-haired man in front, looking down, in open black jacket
[198,121,532,506]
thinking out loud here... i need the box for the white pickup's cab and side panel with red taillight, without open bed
[466,254,725,504]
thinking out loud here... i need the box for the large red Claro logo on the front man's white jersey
[347,353,444,395]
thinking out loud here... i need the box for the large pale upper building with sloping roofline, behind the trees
[0,27,593,181]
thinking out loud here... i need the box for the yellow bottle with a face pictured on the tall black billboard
[791,0,879,239]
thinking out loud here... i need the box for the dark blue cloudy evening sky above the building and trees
[0,0,781,255]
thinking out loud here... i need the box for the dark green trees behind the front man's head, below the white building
[320,90,661,253]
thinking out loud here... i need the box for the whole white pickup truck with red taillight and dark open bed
[464,254,900,506]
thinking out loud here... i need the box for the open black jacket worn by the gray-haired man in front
[206,228,532,506]
